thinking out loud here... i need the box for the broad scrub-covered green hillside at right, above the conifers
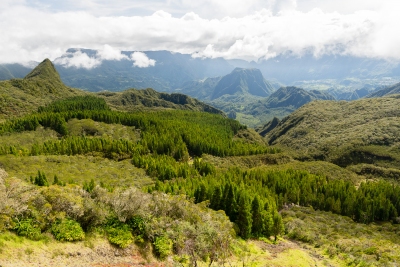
[266,96,400,174]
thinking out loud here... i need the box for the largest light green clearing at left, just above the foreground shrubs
[0,155,153,187]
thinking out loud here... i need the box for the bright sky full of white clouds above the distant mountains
[0,0,400,68]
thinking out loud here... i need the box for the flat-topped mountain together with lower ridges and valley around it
[177,68,335,127]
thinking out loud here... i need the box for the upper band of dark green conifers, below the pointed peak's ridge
[0,97,279,160]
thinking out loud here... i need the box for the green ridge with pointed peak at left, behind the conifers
[0,59,223,119]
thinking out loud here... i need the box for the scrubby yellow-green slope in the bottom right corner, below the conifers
[282,207,400,266]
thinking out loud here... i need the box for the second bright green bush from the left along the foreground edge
[51,219,85,241]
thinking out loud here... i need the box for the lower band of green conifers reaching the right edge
[148,168,400,238]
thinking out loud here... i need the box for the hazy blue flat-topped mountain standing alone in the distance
[211,68,274,100]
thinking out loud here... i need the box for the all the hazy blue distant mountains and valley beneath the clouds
[0,49,400,127]
